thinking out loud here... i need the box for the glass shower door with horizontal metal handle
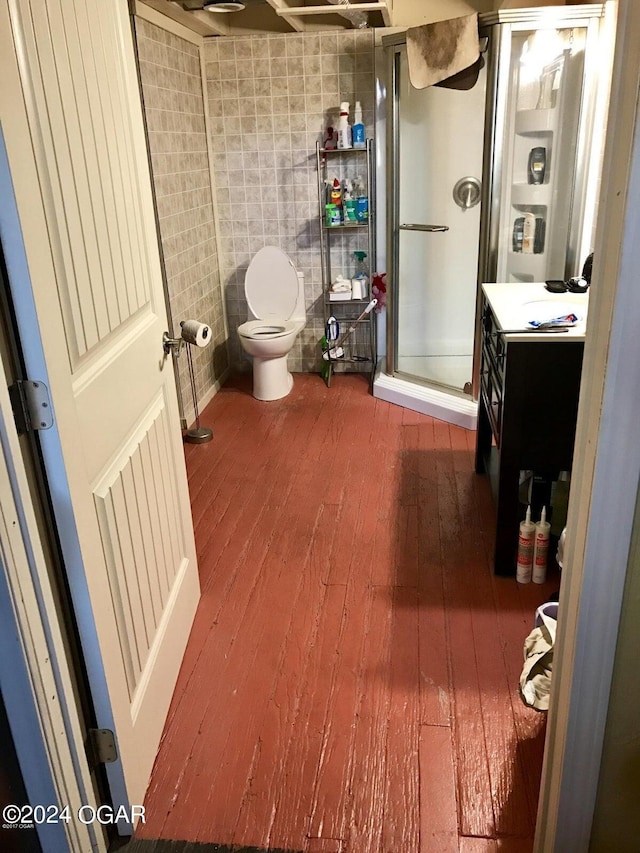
[391,45,485,392]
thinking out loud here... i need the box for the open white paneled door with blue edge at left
[0,0,199,820]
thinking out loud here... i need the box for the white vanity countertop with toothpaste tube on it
[482,282,589,342]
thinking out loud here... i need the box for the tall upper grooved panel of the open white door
[20,2,150,356]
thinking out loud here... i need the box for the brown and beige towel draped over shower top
[407,13,481,89]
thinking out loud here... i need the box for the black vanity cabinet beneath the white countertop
[476,296,584,575]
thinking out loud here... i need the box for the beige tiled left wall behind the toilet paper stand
[136,18,229,423]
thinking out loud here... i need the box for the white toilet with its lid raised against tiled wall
[238,246,307,400]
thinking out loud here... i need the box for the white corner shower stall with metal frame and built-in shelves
[374,4,611,428]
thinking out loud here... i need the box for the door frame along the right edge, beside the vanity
[534,0,640,853]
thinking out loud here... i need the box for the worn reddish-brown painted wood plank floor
[137,375,559,853]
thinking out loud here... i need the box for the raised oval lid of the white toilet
[244,246,298,320]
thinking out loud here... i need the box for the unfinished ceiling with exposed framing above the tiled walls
[142,0,393,36]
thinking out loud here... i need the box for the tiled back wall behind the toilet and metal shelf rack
[204,30,375,371]
